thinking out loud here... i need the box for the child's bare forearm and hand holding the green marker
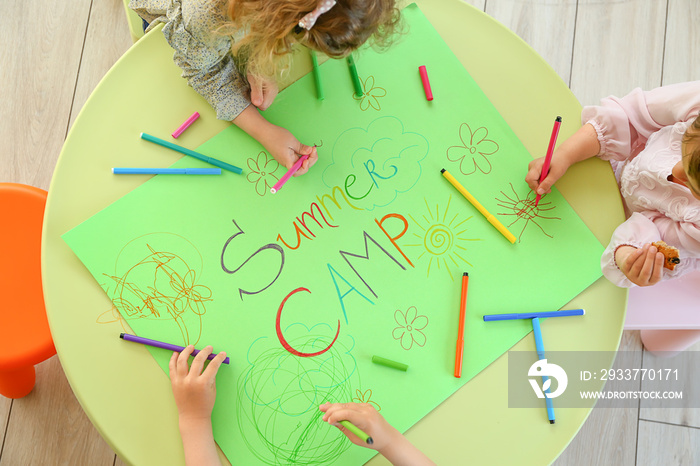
[319,403,435,466]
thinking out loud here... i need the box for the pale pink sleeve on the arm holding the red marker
[581,81,700,160]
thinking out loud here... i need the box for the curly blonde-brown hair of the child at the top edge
[222,0,401,78]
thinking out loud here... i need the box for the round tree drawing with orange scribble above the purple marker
[104,233,212,345]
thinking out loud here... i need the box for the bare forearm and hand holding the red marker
[525,124,600,195]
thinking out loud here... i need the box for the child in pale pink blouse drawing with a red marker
[525,81,700,287]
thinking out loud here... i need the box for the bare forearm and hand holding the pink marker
[233,105,318,176]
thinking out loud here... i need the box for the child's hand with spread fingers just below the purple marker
[170,345,226,422]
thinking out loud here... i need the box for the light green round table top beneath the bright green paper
[42,0,627,465]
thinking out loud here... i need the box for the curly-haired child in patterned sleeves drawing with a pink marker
[129,0,400,176]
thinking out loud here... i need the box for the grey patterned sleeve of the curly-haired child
[129,0,250,121]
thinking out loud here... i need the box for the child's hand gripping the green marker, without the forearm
[319,403,402,451]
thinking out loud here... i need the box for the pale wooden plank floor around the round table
[0,0,700,466]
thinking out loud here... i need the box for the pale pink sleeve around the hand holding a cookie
[600,212,700,288]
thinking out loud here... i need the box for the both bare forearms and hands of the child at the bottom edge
[169,345,434,466]
